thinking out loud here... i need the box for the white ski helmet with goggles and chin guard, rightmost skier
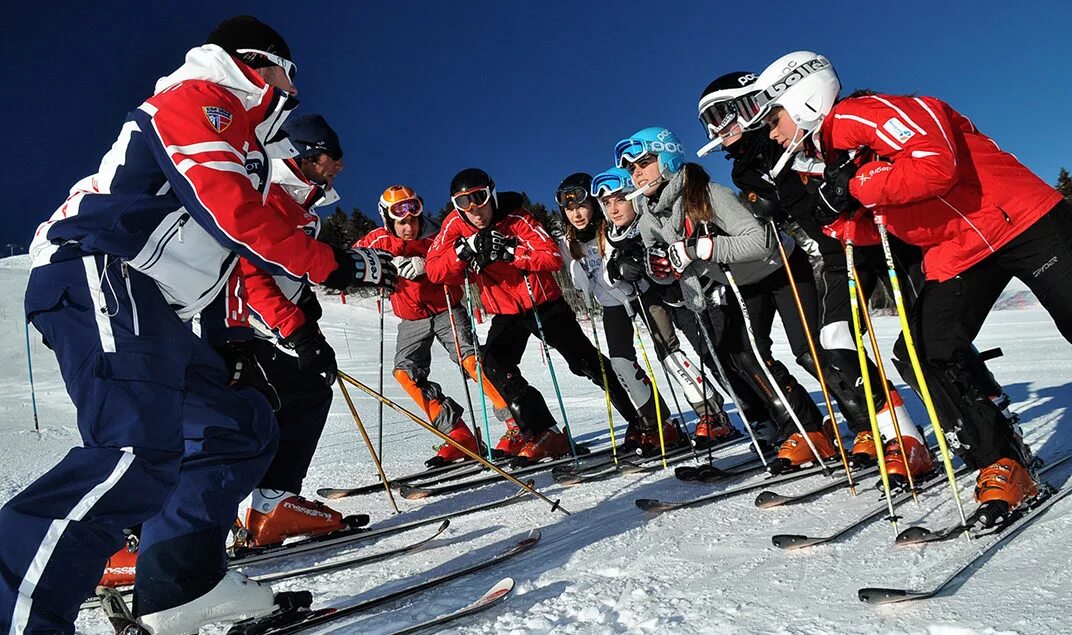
[738,50,842,176]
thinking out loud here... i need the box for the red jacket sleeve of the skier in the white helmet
[830,95,958,208]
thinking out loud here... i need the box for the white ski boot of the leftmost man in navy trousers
[139,571,283,635]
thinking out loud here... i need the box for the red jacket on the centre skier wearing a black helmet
[426,192,562,315]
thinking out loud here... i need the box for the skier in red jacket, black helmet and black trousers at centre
[427,167,640,464]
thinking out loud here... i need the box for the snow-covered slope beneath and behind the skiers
[0,257,1072,634]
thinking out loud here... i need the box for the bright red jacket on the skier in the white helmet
[820,94,1061,281]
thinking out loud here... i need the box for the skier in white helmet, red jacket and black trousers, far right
[745,51,1072,525]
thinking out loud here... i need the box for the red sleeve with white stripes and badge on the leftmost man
[134,82,338,283]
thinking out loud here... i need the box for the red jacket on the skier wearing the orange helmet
[354,218,461,320]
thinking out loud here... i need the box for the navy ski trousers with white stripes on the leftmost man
[0,255,277,633]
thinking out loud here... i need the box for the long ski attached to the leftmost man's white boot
[227,529,540,635]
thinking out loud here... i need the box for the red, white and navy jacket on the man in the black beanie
[30,45,338,320]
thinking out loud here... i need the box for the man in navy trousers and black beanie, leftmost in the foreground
[0,16,393,633]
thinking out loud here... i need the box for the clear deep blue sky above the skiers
[0,0,1072,249]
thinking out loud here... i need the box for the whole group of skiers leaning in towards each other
[0,9,1072,633]
